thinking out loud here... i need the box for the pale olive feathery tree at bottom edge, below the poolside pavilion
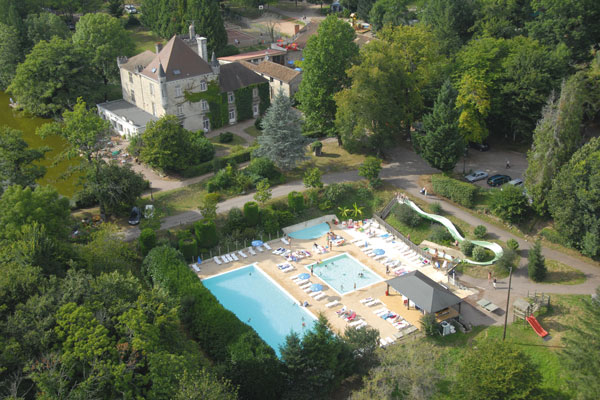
[350,340,441,400]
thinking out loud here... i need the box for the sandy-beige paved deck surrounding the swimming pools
[198,225,471,338]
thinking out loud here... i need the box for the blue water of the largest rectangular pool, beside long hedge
[202,264,315,356]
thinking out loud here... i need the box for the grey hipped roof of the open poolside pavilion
[386,271,462,313]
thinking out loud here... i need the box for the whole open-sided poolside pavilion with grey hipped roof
[386,270,462,322]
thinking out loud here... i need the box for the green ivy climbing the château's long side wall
[185,81,271,129]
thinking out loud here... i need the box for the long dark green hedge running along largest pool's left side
[143,246,283,399]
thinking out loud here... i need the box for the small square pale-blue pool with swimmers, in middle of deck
[306,253,383,294]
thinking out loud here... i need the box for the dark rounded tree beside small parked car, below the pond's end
[83,161,148,215]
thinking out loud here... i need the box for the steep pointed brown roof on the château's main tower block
[142,35,212,82]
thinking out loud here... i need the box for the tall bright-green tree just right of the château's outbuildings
[296,15,358,134]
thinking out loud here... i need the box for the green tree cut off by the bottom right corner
[562,288,600,400]
